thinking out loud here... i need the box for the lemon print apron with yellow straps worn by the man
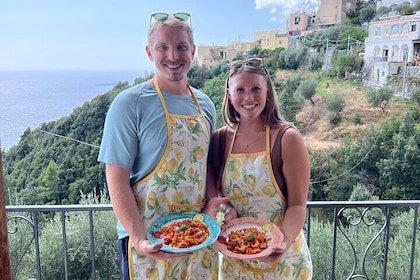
[128,80,218,280]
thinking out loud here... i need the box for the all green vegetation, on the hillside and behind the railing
[3,22,420,279]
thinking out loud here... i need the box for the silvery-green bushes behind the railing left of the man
[9,193,119,280]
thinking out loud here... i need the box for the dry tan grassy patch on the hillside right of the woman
[296,75,410,152]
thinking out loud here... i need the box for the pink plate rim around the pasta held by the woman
[214,217,284,260]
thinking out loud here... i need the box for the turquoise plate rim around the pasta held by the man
[147,212,220,253]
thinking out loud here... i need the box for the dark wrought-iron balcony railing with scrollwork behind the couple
[6,200,420,280]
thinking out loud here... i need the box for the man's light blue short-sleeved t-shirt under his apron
[98,81,216,238]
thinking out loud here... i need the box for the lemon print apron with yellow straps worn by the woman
[220,126,312,280]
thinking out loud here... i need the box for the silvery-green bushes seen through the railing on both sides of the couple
[9,189,420,280]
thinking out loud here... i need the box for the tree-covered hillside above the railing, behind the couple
[3,31,420,205]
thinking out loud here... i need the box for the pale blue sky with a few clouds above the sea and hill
[0,0,320,71]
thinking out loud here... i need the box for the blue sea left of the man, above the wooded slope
[0,71,146,151]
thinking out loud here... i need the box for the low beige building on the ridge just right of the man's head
[195,42,256,68]
